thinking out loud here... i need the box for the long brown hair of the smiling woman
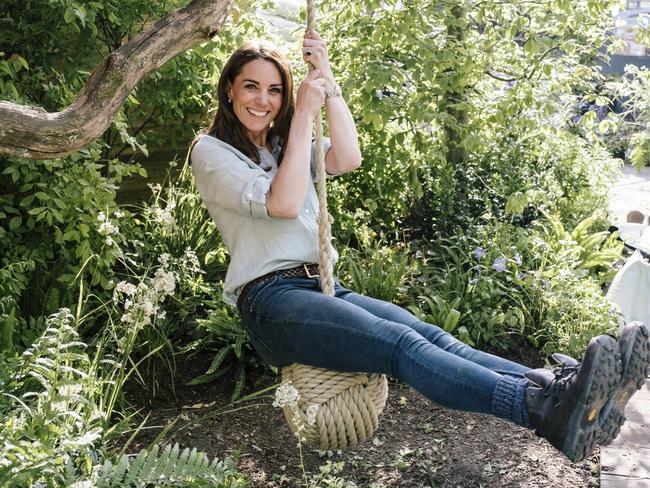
[207,41,294,164]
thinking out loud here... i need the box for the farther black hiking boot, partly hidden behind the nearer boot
[531,322,650,446]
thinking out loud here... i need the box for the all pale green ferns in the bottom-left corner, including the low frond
[0,309,247,487]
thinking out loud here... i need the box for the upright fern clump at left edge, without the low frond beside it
[0,310,106,487]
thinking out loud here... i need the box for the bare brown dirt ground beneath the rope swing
[128,351,599,488]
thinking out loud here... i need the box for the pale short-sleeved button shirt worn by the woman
[190,135,338,305]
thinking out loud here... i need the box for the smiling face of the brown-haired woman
[228,59,284,145]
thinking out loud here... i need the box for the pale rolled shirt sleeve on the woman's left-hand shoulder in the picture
[190,140,271,219]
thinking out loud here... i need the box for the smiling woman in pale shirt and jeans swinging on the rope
[191,31,650,461]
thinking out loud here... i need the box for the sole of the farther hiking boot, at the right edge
[599,322,650,446]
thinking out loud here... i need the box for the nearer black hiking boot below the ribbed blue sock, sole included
[525,335,621,462]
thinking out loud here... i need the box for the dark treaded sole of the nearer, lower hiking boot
[562,336,622,462]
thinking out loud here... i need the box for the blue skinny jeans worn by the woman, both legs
[239,276,529,426]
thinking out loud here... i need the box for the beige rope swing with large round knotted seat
[282,0,388,449]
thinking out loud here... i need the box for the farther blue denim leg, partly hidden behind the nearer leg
[336,285,530,378]
